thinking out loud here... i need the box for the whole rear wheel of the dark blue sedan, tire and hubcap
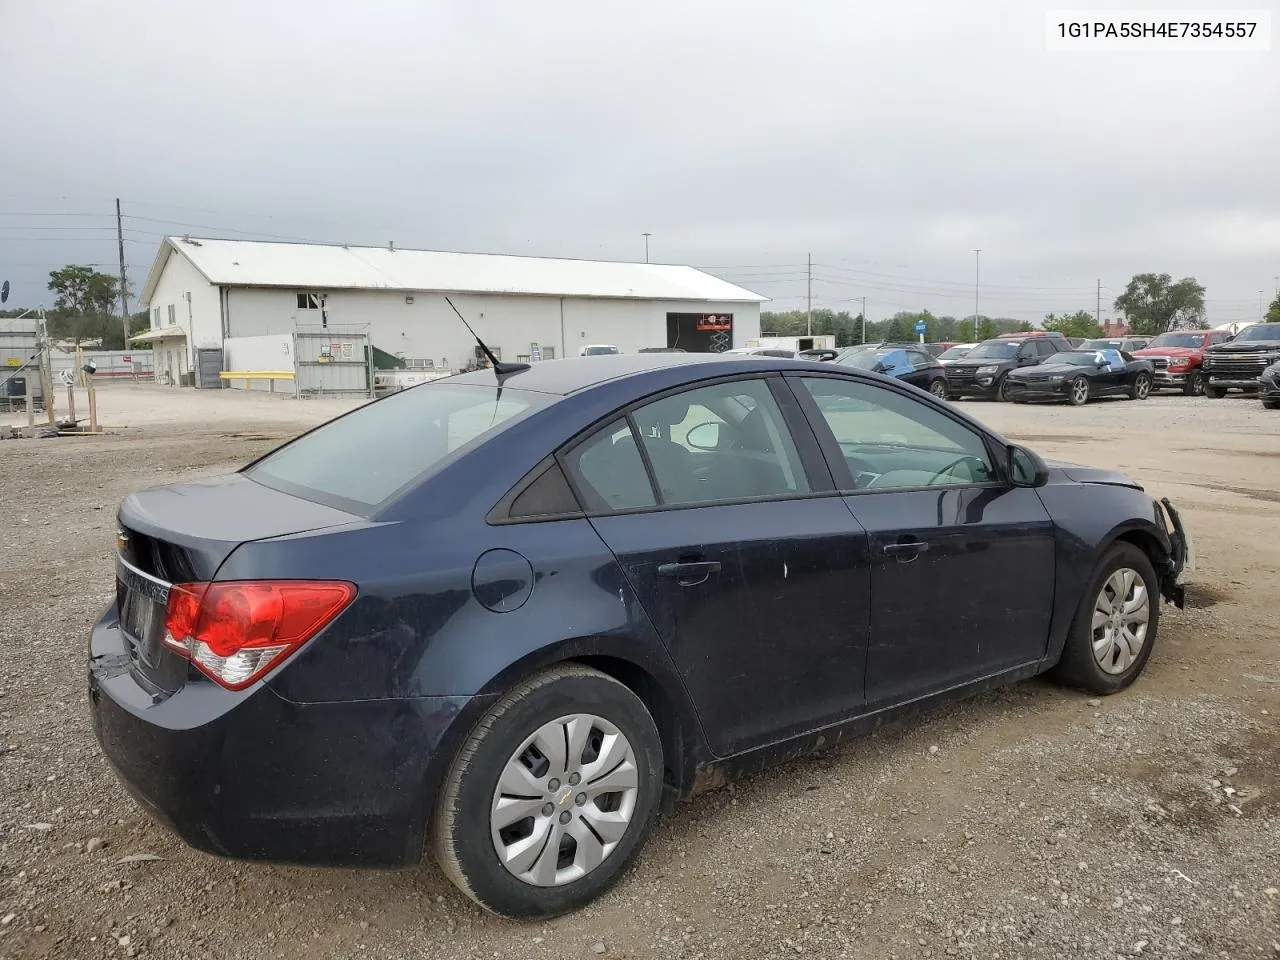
[431,664,663,916]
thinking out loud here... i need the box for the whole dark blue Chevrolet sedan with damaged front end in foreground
[88,353,1189,916]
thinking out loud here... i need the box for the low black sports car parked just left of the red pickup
[1005,349,1155,407]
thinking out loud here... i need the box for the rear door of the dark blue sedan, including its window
[563,376,870,756]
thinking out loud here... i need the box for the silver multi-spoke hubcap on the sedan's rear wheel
[489,713,640,887]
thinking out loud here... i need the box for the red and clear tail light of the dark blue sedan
[164,580,356,690]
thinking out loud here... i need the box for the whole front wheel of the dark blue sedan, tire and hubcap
[1052,543,1160,694]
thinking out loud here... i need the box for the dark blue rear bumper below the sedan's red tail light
[88,608,481,867]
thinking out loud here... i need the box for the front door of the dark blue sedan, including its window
[787,374,1055,709]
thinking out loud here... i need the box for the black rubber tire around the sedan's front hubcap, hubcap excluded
[1050,543,1161,696]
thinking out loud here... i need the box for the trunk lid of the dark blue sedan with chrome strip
[115,474,361,699]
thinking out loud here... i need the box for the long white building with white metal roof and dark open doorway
[133,237,765,394]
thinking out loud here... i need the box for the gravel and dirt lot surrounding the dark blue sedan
[0,385,1280,960]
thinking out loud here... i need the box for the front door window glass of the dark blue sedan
[800,376,1000,490]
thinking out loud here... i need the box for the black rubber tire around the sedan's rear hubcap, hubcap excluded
[431,664,663,918]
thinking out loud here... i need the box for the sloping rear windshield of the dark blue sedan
[244,384,556,515]
